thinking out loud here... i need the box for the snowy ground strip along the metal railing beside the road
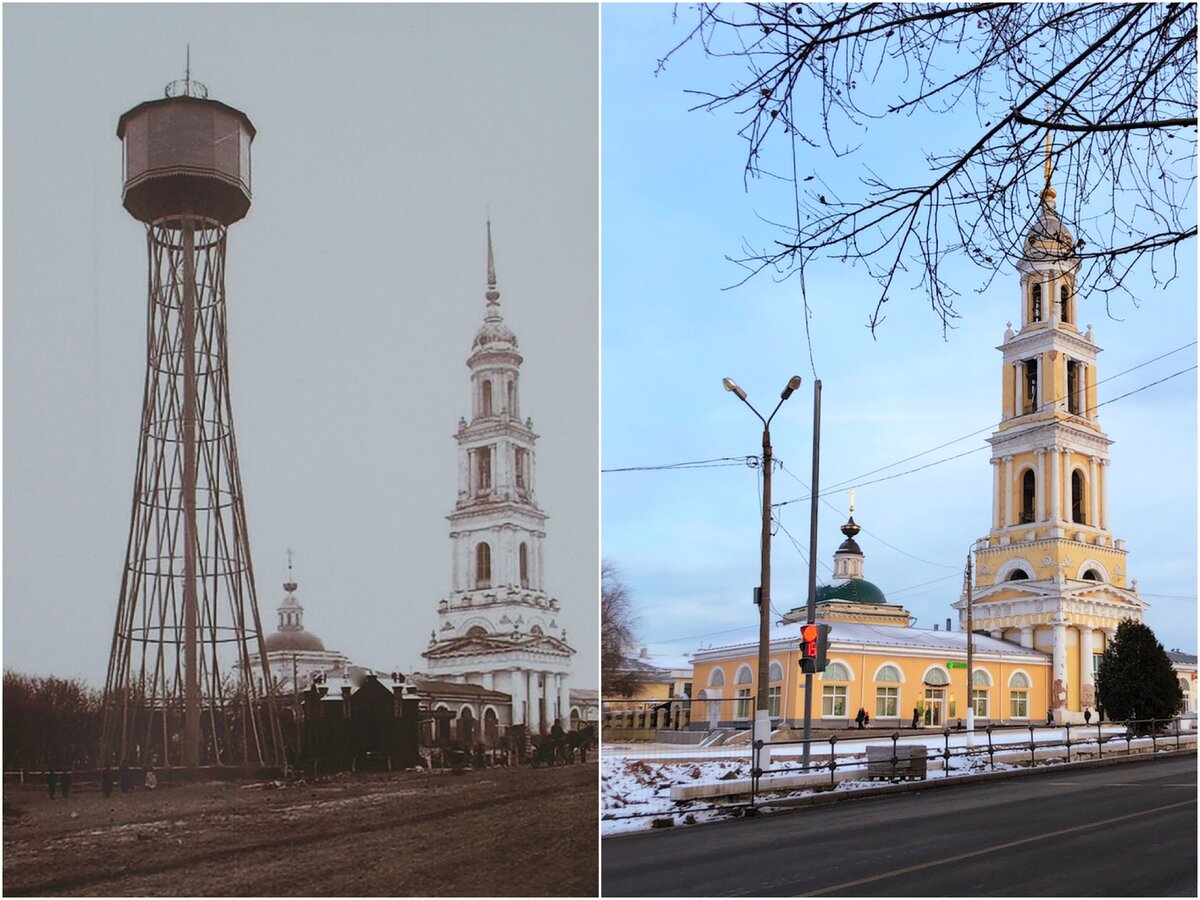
[600,725,1195,836]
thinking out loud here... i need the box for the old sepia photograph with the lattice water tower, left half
[2,4,600,896]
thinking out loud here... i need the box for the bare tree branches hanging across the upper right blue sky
[659,2,1196,334]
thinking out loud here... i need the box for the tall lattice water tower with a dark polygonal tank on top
[101,77,282,767]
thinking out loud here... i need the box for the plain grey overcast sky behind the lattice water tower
[4,4,599,688]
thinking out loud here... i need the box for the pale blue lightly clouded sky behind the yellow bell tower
[601,5,1196,656]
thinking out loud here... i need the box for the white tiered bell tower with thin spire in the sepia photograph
[421,222,575,732]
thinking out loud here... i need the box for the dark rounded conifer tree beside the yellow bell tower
[1096,619,1183,731]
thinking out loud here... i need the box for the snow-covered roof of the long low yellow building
[692,622,1050,660]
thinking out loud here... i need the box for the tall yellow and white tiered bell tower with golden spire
[954,136,1147,721]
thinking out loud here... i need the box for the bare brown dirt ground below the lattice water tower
[4,762,599,896]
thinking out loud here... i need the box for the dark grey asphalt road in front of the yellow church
[601,756,1196,896]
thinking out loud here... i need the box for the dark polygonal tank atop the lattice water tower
[116,96,254,226]
